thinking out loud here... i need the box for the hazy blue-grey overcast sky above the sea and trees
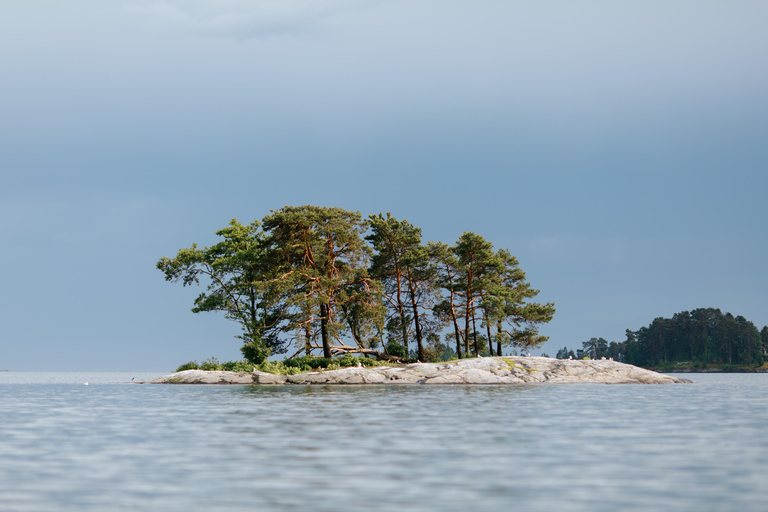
[0,0,768,371]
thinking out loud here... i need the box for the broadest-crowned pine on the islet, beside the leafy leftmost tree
[264,205,384,357]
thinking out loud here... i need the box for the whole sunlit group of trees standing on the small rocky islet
[157,205,555,363]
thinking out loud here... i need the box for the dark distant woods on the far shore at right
[557,308,768,367]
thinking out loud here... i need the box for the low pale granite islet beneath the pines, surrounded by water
[144,356,690,385]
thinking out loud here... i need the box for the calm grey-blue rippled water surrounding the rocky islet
[0,372,768,512]
